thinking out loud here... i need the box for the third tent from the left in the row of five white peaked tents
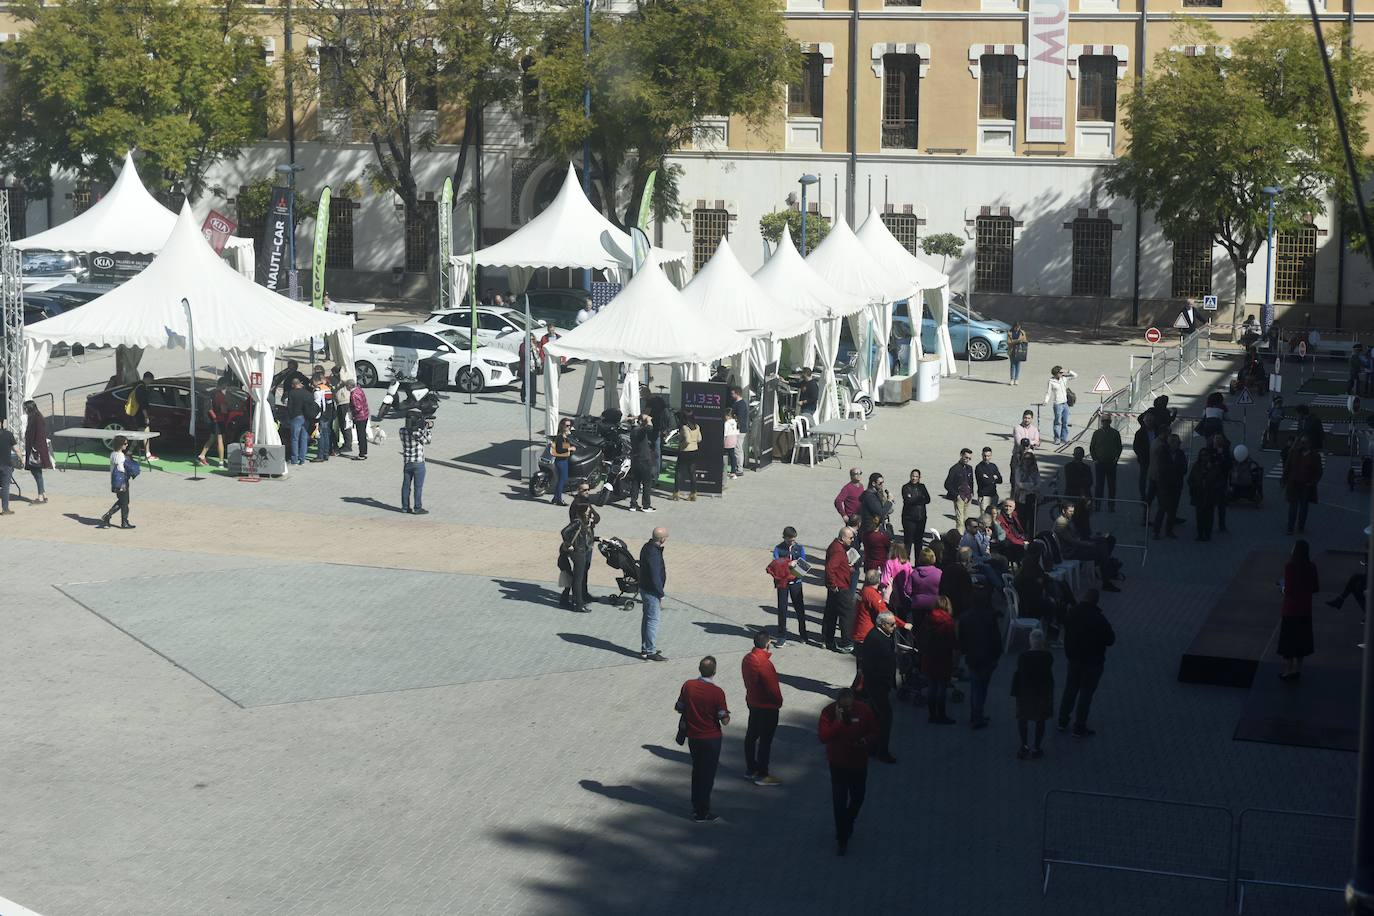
[754,232,867,420]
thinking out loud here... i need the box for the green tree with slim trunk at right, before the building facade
[1107,15,1374,335]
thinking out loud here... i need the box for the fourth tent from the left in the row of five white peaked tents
[807,220,919,400]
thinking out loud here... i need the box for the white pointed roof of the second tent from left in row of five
[683,236,812,339]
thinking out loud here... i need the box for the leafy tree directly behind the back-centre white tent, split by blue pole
[533,0,801,225]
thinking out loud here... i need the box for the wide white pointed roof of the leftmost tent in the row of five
[544,265,749,364]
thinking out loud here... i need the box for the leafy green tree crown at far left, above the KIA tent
[0,0,271,199]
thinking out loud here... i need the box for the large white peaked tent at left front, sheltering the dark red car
[23,206,353,445]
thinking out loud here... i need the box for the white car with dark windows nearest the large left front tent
[353,324,519,391]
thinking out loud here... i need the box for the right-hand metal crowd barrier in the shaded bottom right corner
[1234,808,1355,913]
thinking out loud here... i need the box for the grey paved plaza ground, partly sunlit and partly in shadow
[0,325,1352,916]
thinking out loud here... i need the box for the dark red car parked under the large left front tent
[84,376,278,452]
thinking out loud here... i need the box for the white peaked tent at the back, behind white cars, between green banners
[452,165,686,302]
